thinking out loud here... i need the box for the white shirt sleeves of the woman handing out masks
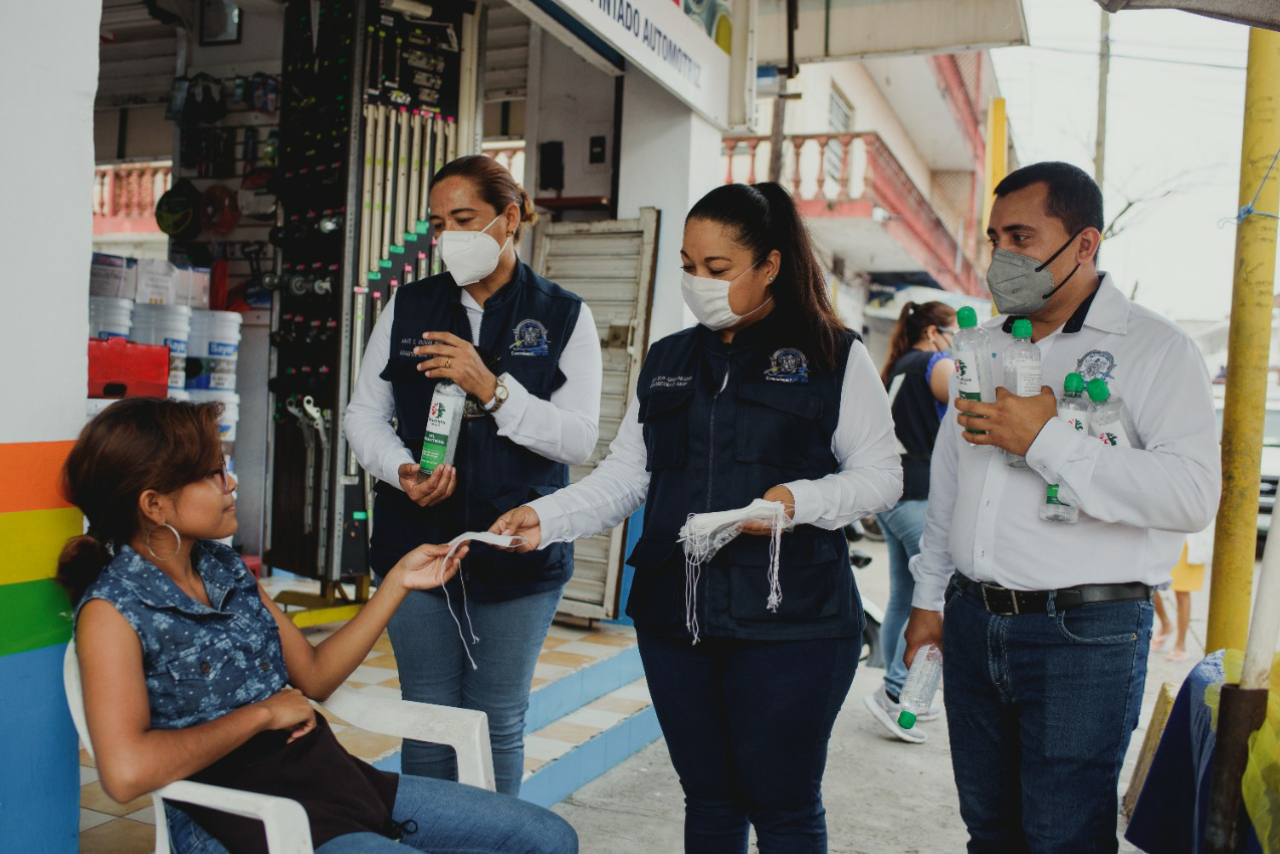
[530,342,902,548]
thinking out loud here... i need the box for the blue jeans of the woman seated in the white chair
[165,775,577,854]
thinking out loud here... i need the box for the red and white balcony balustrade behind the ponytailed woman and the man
[723,132,975,289]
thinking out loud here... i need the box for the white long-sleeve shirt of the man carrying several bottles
[911,275,1222,611]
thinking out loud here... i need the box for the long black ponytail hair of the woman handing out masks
[685,182,849,370]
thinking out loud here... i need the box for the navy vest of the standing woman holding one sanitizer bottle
[370,264,582,602]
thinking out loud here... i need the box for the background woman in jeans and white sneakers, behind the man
[863,301,956,744]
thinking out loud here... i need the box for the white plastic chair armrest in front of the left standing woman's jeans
[321,686,495,791]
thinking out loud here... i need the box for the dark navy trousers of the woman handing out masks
[636,631,861,854]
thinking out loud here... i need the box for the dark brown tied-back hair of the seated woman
[58,397,223,604]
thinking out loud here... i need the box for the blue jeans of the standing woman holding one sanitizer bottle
[387,589,561,795]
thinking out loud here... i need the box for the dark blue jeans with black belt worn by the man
[942,584,1153,854]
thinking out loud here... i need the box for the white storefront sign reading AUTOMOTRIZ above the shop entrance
[556,0,732,128]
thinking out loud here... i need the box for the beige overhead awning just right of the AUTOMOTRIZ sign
[755,0,1027,65]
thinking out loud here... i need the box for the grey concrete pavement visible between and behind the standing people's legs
[554,542,1208,854]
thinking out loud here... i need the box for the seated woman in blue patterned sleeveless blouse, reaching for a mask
[58,398,577,854]
